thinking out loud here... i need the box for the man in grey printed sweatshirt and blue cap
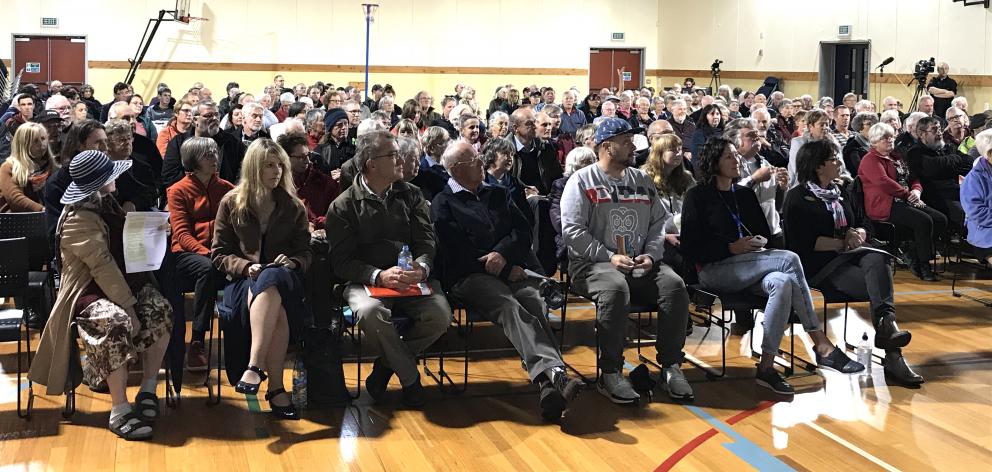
[561,118,693,404]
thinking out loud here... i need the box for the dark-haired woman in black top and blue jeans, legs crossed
[682,137,865,395]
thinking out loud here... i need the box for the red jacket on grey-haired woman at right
[858,149,923,221]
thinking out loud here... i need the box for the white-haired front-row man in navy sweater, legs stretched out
[431,141,581,421]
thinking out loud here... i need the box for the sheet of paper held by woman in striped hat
[124,211,169,274]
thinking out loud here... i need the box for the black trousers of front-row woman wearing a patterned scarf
[819,252,896,325]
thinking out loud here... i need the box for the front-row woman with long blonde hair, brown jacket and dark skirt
[211,138,312,420]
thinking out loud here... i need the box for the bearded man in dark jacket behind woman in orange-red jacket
[162,101,247,188]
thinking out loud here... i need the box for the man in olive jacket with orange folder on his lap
[326,131,451,407]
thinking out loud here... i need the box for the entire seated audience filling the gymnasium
[0,76,992,439]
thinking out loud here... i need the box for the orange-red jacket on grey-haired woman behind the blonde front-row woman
[166,174,234,257]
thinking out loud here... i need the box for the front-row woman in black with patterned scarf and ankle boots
[784,138,923,385]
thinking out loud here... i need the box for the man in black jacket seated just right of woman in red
[906,113,973,228]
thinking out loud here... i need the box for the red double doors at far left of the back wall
[11,35,86,92]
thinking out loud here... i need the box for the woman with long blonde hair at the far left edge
[0,122,56,213]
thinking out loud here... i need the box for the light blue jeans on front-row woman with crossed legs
[699,249,821,356]
